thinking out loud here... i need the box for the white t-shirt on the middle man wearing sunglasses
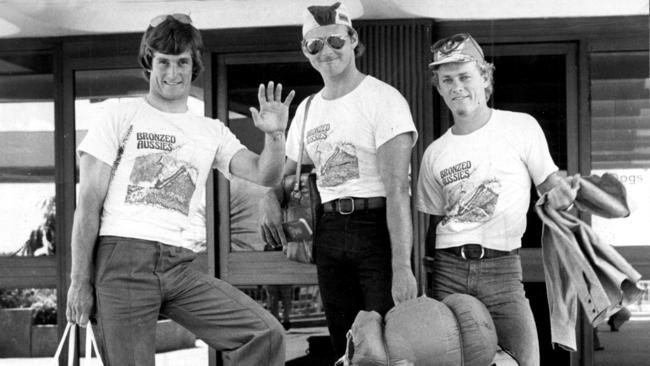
[287,76,417,202]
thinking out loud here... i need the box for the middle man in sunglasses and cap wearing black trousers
[262,3,417,355]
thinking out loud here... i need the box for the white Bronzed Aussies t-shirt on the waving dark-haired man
[77,99,245,250]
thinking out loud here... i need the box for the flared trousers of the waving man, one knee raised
[95,237,285,366]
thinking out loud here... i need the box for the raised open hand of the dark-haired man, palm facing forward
[250,81,296,134]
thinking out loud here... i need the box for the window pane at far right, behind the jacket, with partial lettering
[590,52,650,245]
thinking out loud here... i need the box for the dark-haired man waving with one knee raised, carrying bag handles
[66,14,294,366]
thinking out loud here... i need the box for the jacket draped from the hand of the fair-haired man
[535,174,643,351]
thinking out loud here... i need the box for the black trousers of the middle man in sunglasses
[314,208,393,356]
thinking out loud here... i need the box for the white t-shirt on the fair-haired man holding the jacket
[416,110,558,251]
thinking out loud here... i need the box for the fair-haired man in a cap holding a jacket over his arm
[416,34,578,366]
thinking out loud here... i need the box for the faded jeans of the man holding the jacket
[431,250,539,366]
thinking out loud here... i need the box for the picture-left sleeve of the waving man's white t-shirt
[77,103,132,166]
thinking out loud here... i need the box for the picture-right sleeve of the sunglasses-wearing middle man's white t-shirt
[372,86,418,148]
